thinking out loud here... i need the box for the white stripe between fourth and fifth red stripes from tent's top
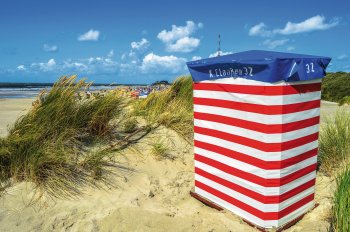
[194,133,318,161]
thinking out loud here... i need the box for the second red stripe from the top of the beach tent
[193,97,321,115]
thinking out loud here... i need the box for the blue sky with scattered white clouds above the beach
[0,0,350,84]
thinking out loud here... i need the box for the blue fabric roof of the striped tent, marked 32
[187,50,331,83]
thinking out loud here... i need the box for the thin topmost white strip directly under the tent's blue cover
[200,77,322,86]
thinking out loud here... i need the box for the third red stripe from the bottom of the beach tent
[194,154,317,187]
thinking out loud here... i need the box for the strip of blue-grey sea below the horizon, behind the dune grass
[0,85,115,98]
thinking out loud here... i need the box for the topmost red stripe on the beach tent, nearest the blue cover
[193,83,321,96]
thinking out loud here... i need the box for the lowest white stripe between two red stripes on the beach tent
[195,174,315,212]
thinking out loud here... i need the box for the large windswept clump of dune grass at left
[0,76,124,197]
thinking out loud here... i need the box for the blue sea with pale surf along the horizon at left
[0,83,120,99]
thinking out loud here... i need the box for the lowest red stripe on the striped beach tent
[195,181,314,220]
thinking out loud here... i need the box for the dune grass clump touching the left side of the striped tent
[134,77,193,141]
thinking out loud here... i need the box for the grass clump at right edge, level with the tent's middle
[319,109,350,175]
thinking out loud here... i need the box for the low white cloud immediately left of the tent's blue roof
[140,52,187,74]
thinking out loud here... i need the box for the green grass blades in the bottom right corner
[331,166,350,232]
